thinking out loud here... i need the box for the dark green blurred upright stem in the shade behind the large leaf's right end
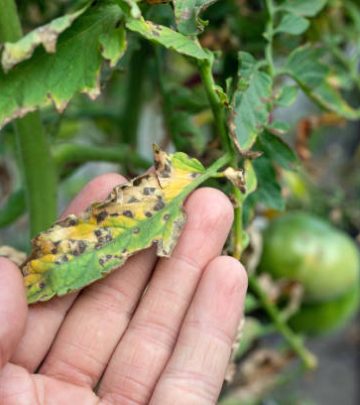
[121,41,149,148]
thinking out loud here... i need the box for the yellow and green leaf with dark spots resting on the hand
[22,148,226,303]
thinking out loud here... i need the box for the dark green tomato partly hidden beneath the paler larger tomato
[289,286,360,335]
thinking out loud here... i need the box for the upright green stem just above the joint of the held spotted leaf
[198,60,234,154]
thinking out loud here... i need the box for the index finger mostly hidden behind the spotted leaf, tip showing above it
[11,173,124,371]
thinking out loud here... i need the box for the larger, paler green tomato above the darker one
[260,212,360,302]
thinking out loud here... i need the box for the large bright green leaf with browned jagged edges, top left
[0,1,124,128]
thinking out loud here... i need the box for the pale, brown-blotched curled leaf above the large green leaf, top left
[1,7,87,72]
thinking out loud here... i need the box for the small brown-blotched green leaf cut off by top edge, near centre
[174,0,217,35]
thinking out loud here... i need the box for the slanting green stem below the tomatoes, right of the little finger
[249,275,317,369]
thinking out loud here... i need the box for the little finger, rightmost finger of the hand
[150,257,247,405]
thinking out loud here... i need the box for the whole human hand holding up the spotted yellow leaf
[0,174,247,405]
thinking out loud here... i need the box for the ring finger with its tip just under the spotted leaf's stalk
[99,188,233,404]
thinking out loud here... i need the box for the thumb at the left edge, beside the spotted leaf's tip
[0,257,27,369]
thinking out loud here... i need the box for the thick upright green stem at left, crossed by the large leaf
[0,0,57,236]
